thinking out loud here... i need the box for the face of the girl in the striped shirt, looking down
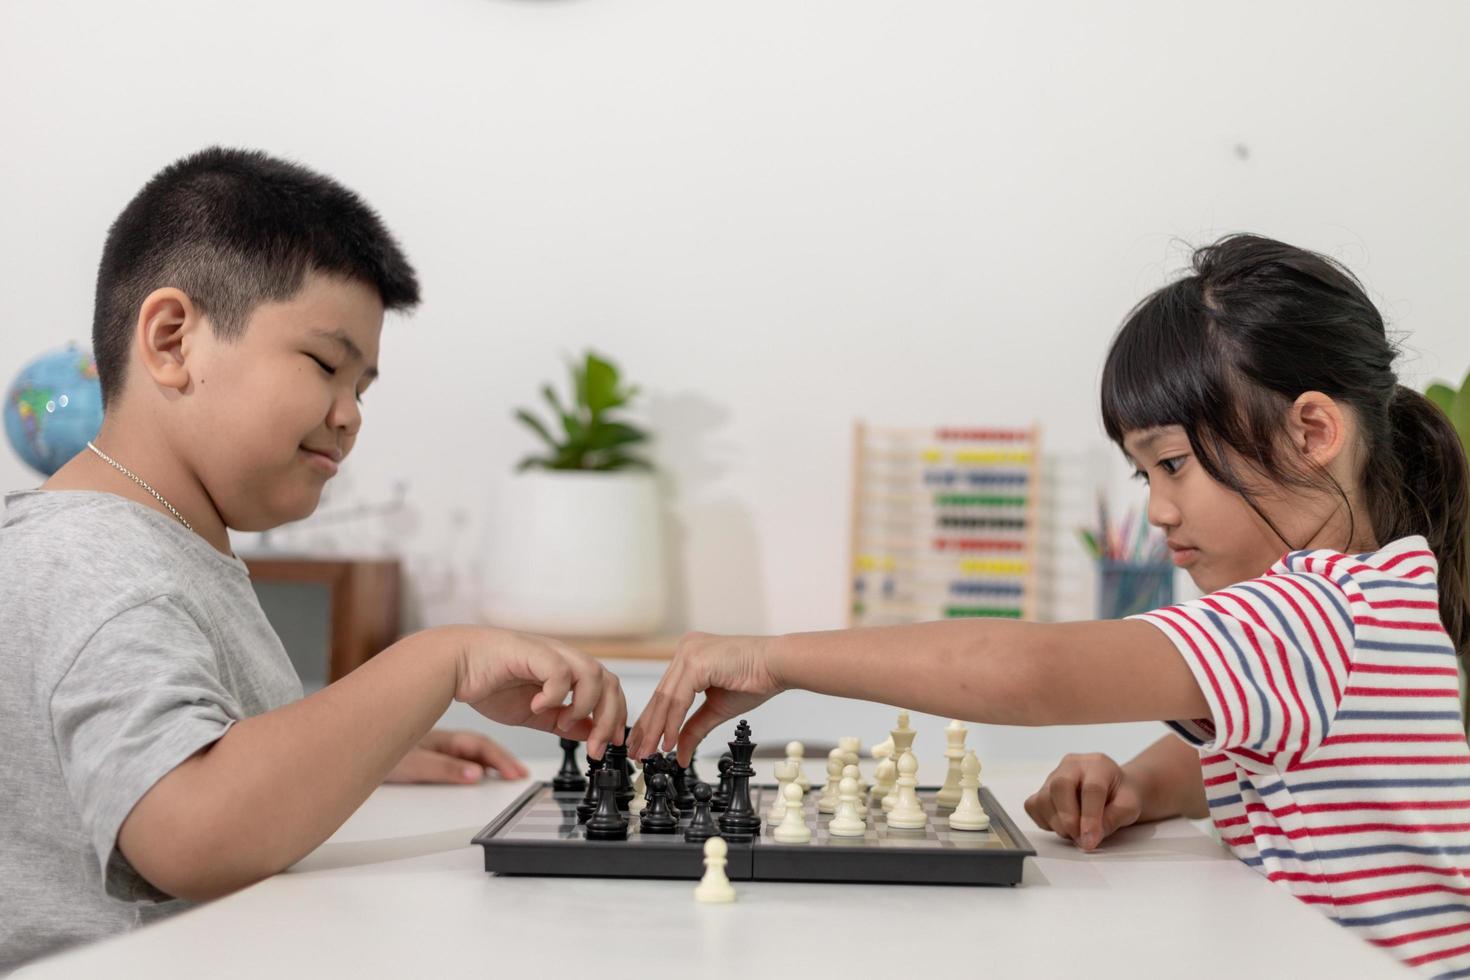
[1123,426,1342,592]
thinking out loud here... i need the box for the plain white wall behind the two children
[0,0,1470,764]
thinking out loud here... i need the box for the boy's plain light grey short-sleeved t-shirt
[0,491,301,973]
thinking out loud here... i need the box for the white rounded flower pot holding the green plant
[481,470,666,636]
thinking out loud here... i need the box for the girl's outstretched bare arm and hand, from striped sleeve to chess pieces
[629,620,1210,758]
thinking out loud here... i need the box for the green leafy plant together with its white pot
[482,351,666,636]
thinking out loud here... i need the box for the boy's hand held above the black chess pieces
[454,629,628,758]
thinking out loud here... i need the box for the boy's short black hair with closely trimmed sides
[93,147,419,404]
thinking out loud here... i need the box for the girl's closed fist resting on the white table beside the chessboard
[1026,752,1144,851]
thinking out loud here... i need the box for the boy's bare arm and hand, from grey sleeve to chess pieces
[118,627,626,901]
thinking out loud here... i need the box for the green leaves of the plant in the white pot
[516,351,653,472]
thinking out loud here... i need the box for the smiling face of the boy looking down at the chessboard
[188,273,382,530]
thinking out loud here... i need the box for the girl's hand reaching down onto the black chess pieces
[628,633,784,765]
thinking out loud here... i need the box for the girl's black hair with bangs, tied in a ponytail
[1103,235,1470,667]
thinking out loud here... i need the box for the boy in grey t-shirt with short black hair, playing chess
[0,148,626,973]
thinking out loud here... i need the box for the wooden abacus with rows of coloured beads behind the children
[847,422,1042,626]
